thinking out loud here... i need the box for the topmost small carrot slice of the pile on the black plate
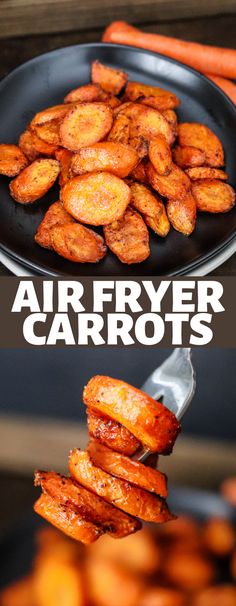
[91,61,128,95]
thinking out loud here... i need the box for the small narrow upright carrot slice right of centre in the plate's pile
[148,135,172,175]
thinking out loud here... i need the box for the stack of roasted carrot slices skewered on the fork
[34,376,180,543]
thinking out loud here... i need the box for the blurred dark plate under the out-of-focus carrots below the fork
[0,488,236,588]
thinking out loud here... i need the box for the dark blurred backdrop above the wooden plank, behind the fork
[0,347,236,440]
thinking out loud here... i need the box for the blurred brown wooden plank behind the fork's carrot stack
[0,414,236,489]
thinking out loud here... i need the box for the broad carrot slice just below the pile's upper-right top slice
[118,102,174,144]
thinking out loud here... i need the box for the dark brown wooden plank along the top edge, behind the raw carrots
[0,0,236,38]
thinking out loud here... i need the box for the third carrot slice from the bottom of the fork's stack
[69,448,173,523]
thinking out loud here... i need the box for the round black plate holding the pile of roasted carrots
[0,43,236,276]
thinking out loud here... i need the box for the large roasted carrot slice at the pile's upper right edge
[178,122,224,167]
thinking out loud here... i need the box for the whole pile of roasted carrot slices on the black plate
[0,59,235,267]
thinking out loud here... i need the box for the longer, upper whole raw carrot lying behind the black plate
[102,21,236,79]
